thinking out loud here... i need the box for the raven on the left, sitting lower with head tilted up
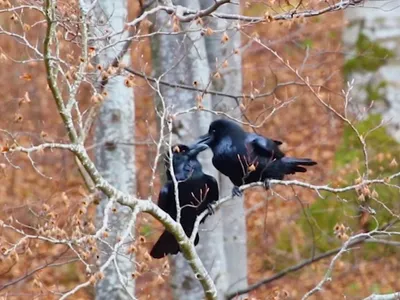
[150,144,219,258]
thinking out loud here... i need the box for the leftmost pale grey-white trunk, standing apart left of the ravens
[92,0,136,300]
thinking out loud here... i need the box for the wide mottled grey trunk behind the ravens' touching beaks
[152,0,227,300]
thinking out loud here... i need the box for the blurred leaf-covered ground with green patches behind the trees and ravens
[0,3,400,299]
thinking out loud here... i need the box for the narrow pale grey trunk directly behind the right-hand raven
[201,0,247,299]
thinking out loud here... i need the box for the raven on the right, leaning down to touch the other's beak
[197,119,317,195]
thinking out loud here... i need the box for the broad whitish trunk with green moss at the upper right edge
[343,0,400,142]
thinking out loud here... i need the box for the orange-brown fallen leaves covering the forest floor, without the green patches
[0,3,398,299]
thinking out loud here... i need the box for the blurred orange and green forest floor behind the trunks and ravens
[0,0,400,299]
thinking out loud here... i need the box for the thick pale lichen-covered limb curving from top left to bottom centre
[44,0,217,300]
